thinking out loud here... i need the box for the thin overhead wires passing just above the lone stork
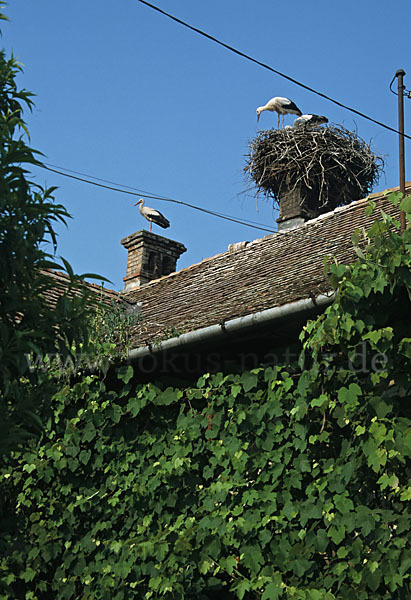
[41,163,276,233]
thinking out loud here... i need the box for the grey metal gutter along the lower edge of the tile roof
[127,292,335,361]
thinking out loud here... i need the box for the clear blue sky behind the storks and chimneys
[2,0,411,290]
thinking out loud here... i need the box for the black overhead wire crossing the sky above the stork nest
[137,0,411,140]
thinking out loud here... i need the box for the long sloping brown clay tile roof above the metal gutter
[124,183,411,348]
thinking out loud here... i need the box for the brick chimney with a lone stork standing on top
[121,229,187,293]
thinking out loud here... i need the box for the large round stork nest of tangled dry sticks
[244,125,384,216]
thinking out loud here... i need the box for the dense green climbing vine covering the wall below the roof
[0,196,411,600]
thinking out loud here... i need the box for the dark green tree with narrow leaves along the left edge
[0,3,104,456]
